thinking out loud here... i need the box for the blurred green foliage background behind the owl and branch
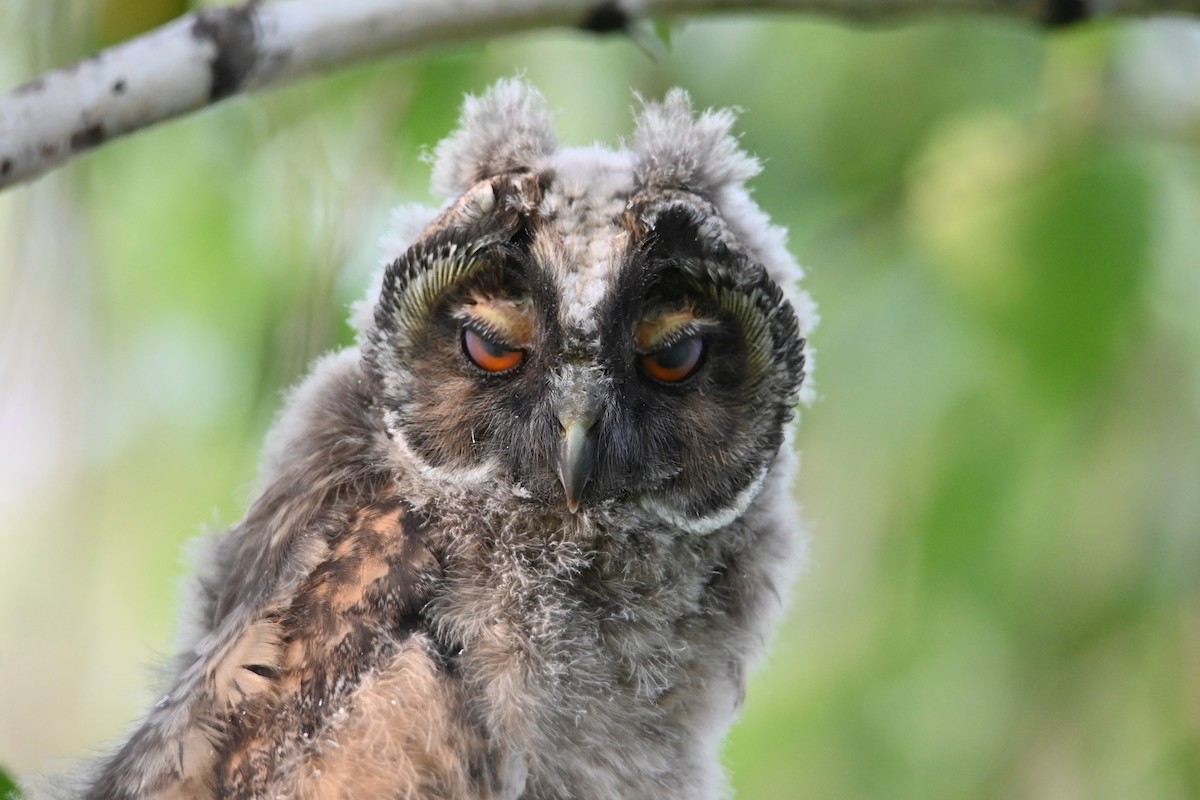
[0,0,1200,800]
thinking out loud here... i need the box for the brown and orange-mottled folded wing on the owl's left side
[86,356,487,800]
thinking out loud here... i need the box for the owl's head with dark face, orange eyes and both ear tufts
[362,80,814,531]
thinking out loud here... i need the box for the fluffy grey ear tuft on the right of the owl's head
[634,89,760,198]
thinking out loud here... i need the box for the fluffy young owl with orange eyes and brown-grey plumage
[35,80,815,800]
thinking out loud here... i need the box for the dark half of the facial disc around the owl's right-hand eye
[594,204,803,516]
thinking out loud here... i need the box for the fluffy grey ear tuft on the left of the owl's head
[433,78,558,198]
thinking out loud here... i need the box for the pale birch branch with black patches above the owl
[0,0,1200,190]
